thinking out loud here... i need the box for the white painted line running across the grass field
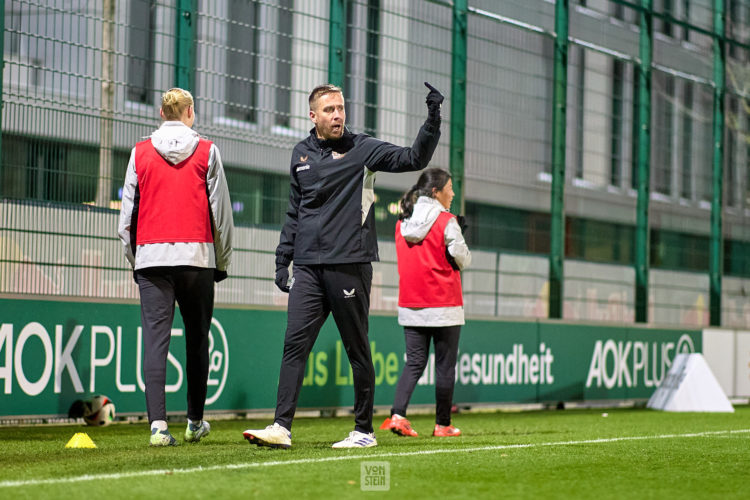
[0,429,750,488]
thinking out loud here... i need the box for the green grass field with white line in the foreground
[0,407,750,500]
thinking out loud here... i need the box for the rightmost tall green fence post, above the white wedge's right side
[709,0,726,326]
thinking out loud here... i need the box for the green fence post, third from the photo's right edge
[548,0,568,319]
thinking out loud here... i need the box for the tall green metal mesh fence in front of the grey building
[0,0,750,327]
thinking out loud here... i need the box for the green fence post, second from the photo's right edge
[635,0,653,323]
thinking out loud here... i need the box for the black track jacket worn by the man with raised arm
[276,119,440,266]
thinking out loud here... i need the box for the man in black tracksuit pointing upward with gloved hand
[244,83,443,448]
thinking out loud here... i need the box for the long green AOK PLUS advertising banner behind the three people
[0,300,702,416]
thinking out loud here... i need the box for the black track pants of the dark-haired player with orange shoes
[391,326,461,425]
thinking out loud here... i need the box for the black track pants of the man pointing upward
[274,263,375,432]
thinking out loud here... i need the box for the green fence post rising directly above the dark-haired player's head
[450,0,468,214]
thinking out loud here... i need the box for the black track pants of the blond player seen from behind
[136,266,214,422]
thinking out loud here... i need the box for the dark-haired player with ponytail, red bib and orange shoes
[380,168,471,437]
